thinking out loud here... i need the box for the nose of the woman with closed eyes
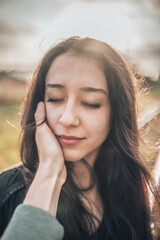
[59,103,80,127]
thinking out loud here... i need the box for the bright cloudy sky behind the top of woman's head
[0,0,160,79]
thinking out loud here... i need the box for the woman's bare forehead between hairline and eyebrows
[46,53,107,89]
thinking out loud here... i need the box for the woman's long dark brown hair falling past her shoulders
[21,37,159,240]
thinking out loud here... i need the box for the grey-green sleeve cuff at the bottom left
[1,204,64,240]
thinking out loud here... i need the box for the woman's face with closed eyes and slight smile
[45,53,111,164]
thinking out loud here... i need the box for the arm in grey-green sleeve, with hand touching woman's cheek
[2,103,66,240]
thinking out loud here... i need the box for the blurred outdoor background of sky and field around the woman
[0,0,160,236]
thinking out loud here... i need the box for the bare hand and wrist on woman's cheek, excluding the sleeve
[24,102,66,217]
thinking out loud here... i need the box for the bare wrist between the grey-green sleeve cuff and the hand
[24,165,64,216]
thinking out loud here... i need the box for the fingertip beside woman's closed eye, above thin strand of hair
[34,102,45,126]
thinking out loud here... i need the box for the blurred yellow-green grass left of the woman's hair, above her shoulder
[0,103,20,170]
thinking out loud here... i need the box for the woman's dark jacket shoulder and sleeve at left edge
[0,164,31,237]
